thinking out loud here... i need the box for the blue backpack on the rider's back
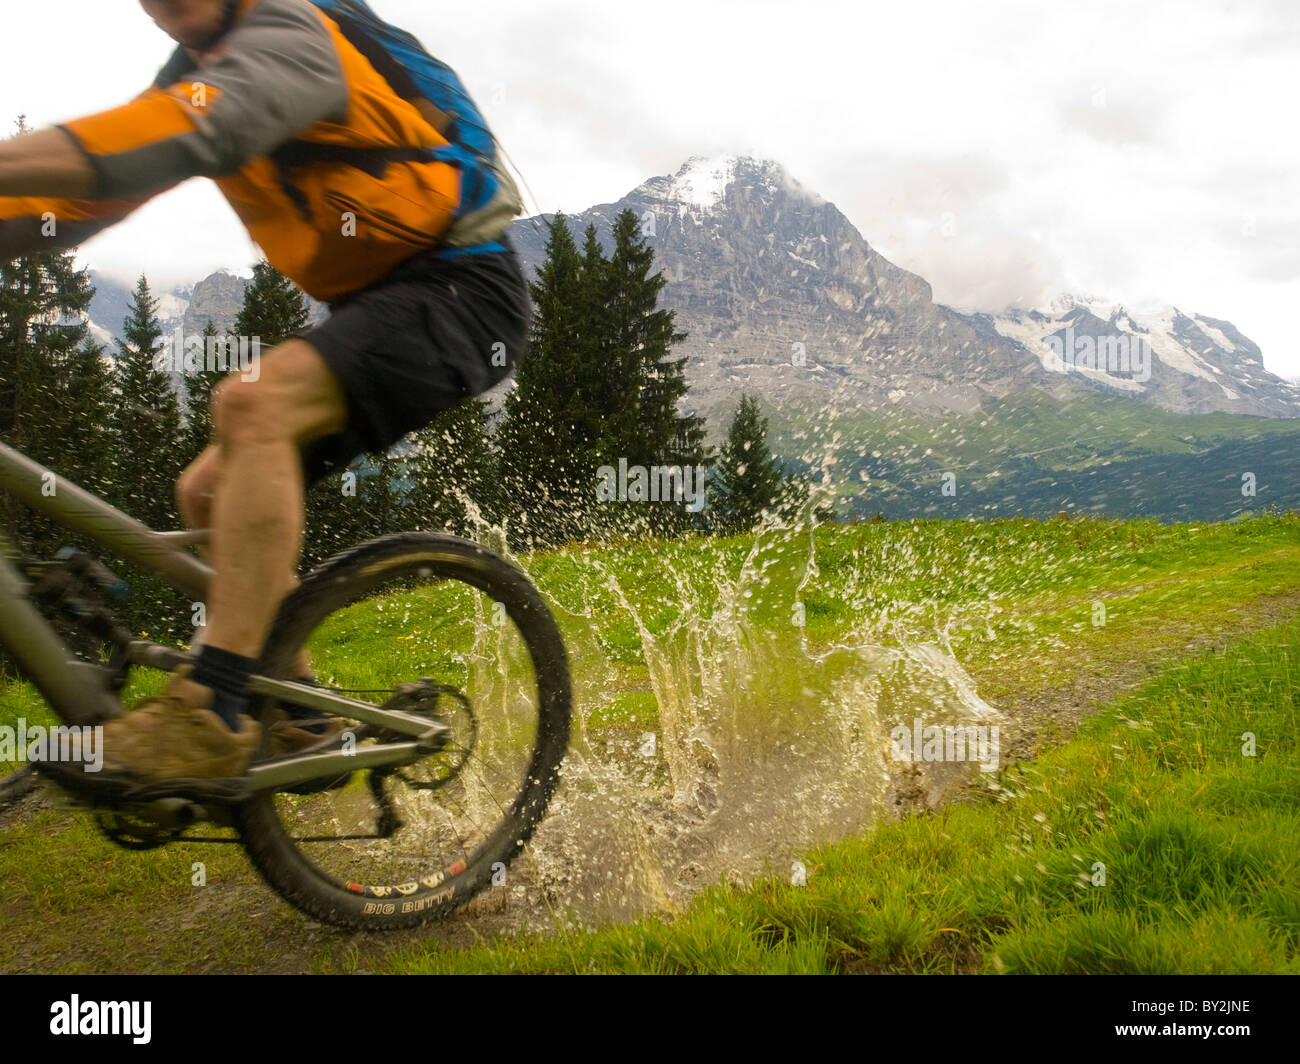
[311,0,523,251]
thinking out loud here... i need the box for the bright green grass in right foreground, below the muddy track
[387,622,1300,973]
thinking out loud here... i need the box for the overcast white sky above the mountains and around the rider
[0,0,1300,376]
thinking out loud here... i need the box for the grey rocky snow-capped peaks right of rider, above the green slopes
[512,156,1300,416]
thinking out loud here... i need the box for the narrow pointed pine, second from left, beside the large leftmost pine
[109,276,183,529]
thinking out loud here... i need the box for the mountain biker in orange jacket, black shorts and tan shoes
[0,0,530,780]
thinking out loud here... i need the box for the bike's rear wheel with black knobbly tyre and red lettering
[239,533,571,930]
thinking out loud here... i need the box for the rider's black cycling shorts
[298,243,532,484]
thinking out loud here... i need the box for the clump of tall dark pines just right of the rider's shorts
[498,211,707,542]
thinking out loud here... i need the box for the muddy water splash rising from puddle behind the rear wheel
[436,483,1005,927]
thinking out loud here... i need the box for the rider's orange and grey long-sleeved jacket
[0,0,520,302]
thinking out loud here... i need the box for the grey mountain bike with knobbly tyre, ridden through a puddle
[0,434,571,930]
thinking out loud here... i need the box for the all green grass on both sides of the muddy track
[0,514,1300,972]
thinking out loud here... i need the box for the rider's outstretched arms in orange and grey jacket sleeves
[0,4,347,258]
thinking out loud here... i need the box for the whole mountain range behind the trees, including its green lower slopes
[71,156,1300,520]
